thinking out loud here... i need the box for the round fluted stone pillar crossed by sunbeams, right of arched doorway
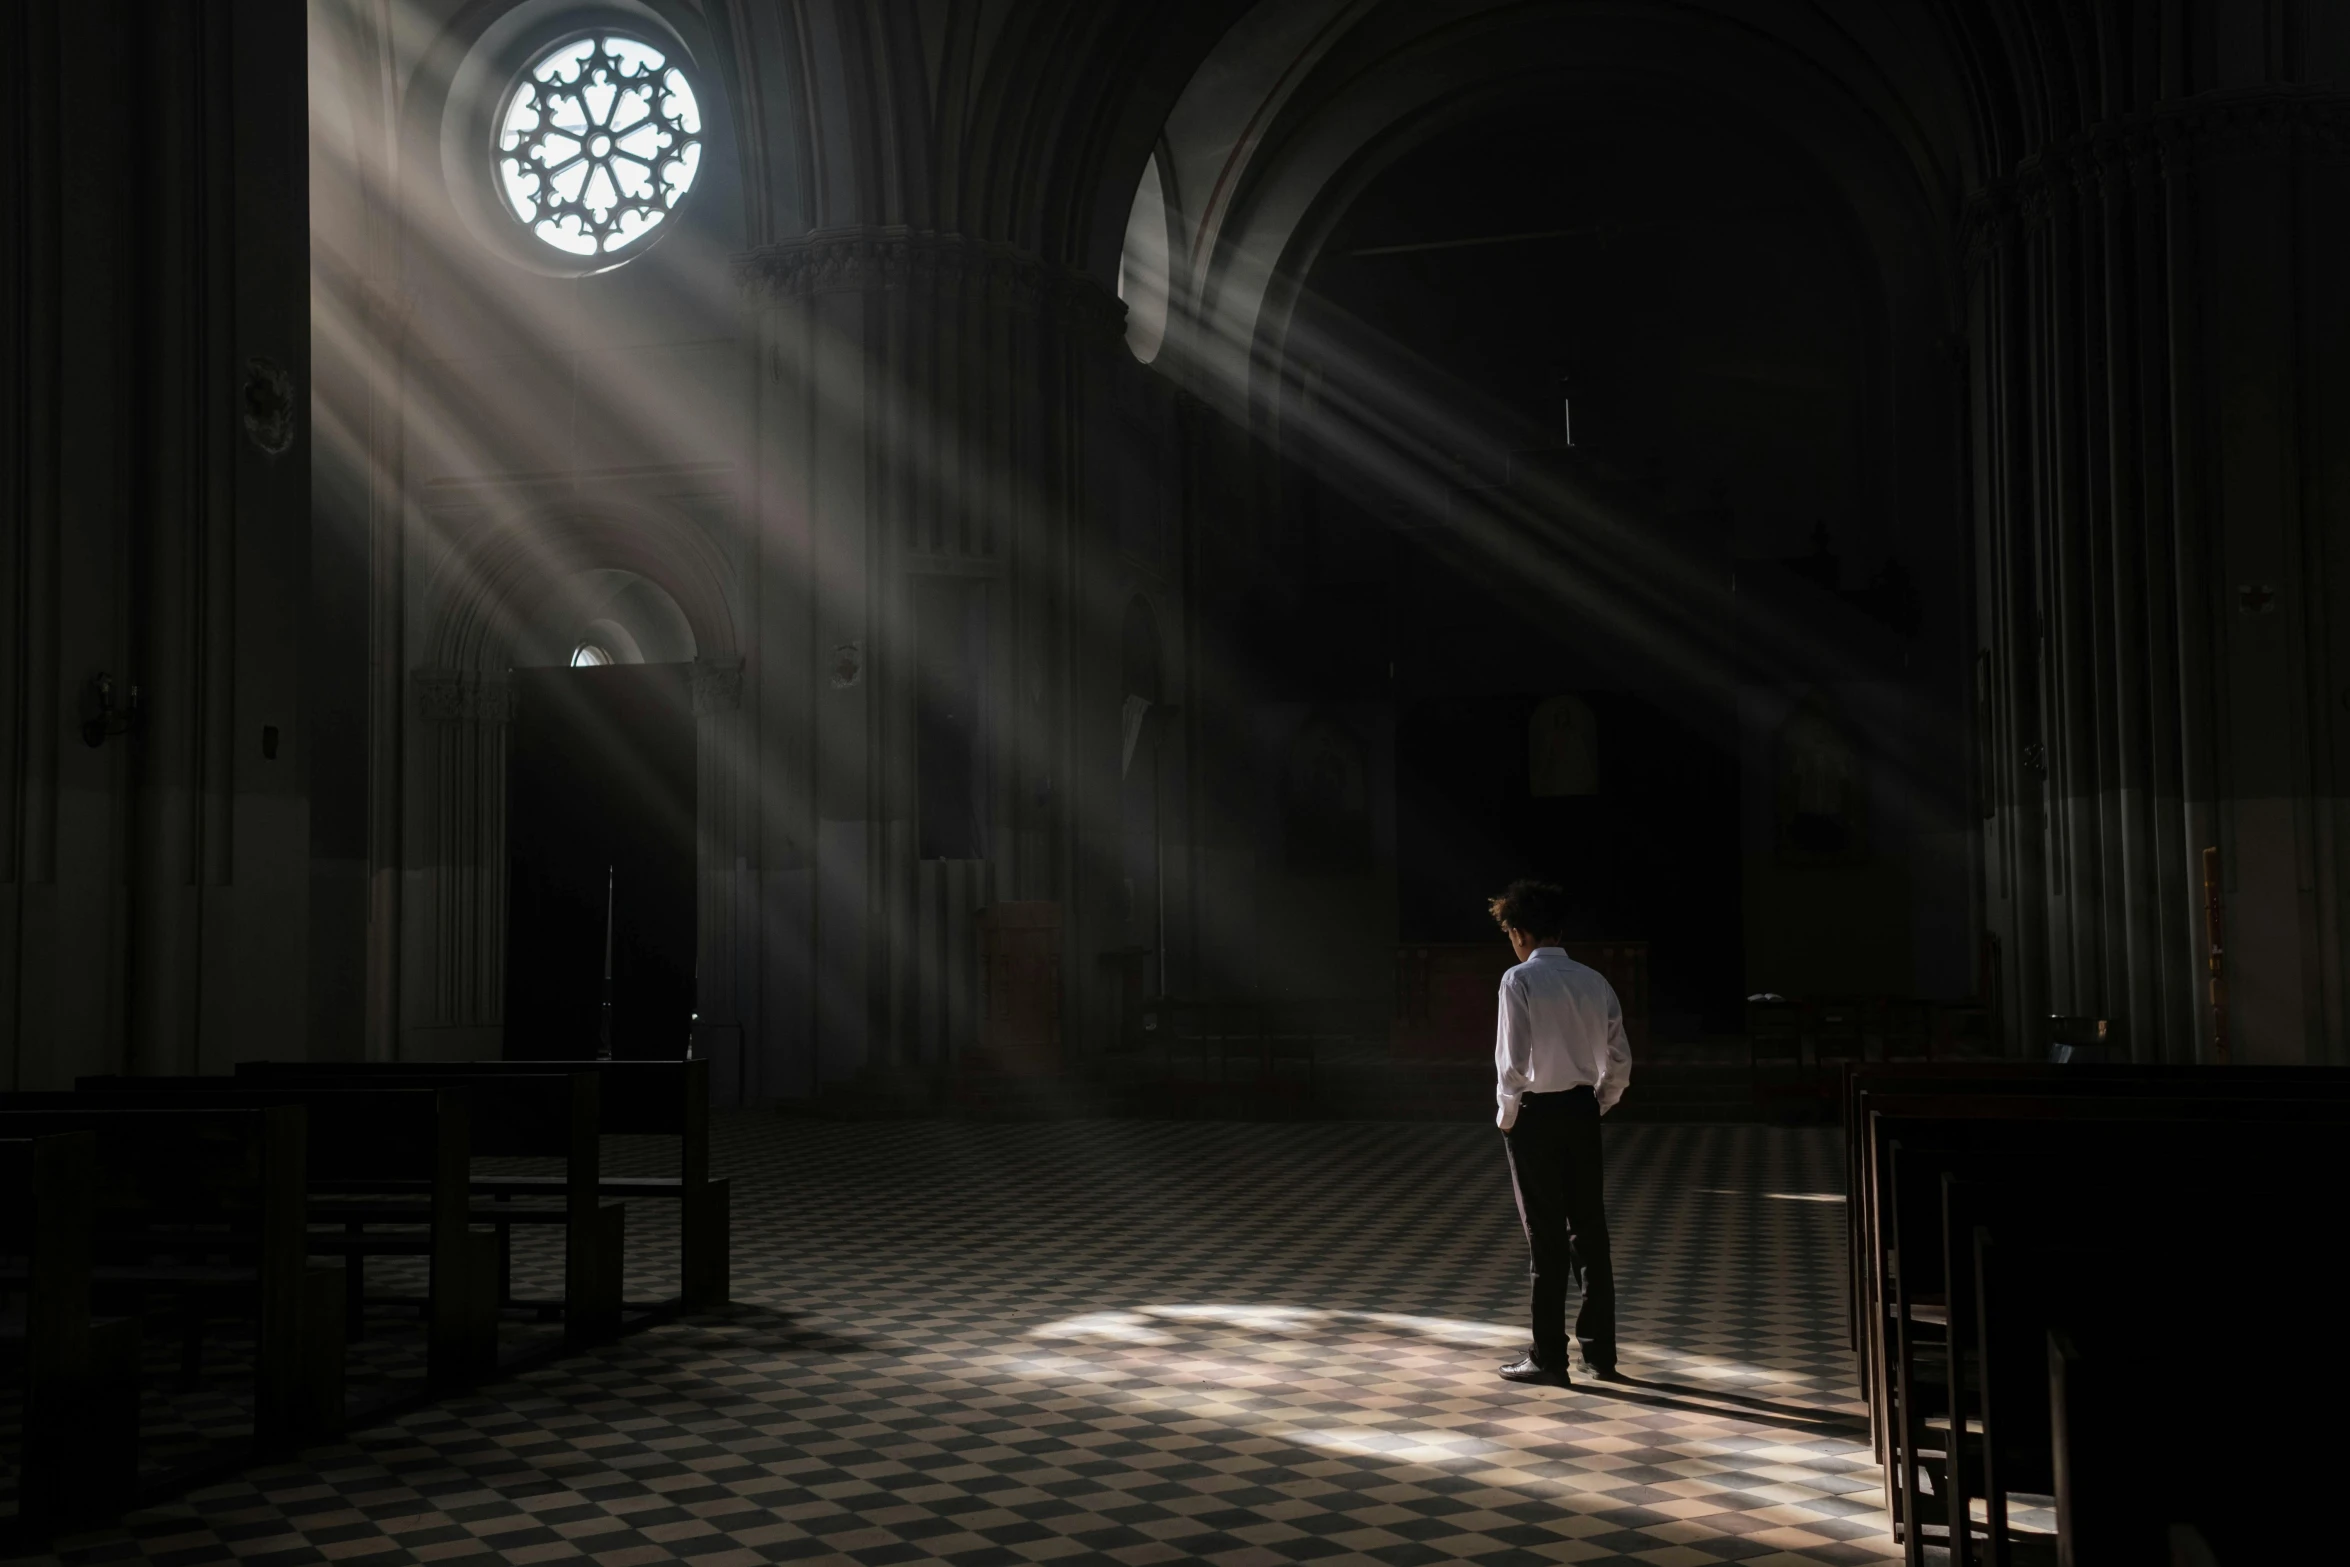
[738,228,1123,1097]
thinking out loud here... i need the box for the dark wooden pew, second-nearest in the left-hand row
[0,1104,343,1447]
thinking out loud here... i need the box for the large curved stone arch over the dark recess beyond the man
[1121,0,1960,435]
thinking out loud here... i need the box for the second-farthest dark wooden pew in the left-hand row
[222,1062,627,1344]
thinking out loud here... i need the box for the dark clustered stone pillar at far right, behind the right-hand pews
[1969,89,2350,1060]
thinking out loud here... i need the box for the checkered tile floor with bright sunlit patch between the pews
[27,1116,1896,1567]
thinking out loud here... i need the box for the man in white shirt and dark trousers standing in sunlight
[1488,881,1631,1386]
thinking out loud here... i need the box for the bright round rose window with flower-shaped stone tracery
[498,33,703,256]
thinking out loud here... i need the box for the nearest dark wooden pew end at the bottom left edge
[0,1132,139,1536]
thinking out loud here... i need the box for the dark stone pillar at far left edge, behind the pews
[0,0,310,1088]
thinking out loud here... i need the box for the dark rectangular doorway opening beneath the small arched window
[505,665,696,1060]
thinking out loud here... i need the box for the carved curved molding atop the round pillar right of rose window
[733,228,1126,336]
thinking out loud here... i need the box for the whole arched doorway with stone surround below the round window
[402,495,757,1071]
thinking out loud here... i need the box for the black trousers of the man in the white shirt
[1502,1088,1614,1367]
